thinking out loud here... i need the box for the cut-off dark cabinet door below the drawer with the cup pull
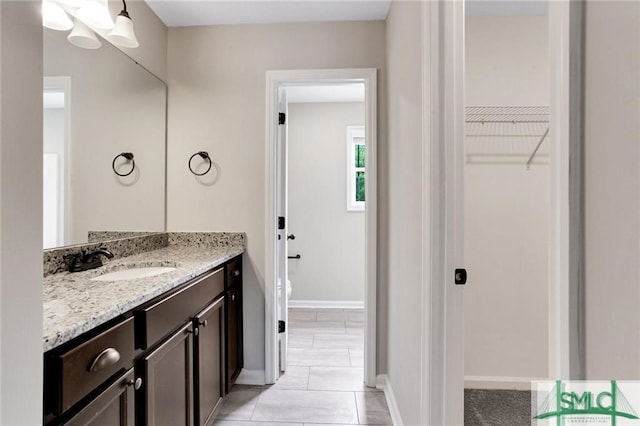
[63,368,135,426]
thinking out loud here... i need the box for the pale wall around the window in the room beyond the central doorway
[288,102,365,302]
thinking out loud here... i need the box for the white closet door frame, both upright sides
[420,0,585,425]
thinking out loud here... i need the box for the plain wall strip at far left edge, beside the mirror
[0,1,42,425]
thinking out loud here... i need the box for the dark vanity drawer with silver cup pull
[54,318,134,414]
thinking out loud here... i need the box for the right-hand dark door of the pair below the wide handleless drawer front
[193,297,224,426]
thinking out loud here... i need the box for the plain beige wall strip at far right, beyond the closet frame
[584,1,640,380]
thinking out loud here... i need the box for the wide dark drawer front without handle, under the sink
[134,268,224,349]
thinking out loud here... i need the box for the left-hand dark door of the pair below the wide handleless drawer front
[139,322,193,426]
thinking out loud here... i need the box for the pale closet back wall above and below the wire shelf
[464,16,552,388]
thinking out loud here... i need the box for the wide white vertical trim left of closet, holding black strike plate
[420,0,464,426]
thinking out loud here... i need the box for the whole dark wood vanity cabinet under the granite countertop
[44,256,243,426]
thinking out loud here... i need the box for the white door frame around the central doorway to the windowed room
[264,68,378,387]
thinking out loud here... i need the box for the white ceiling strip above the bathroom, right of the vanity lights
[145,0,391,27]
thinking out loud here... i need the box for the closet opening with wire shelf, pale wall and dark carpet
[464,1,554,425]
